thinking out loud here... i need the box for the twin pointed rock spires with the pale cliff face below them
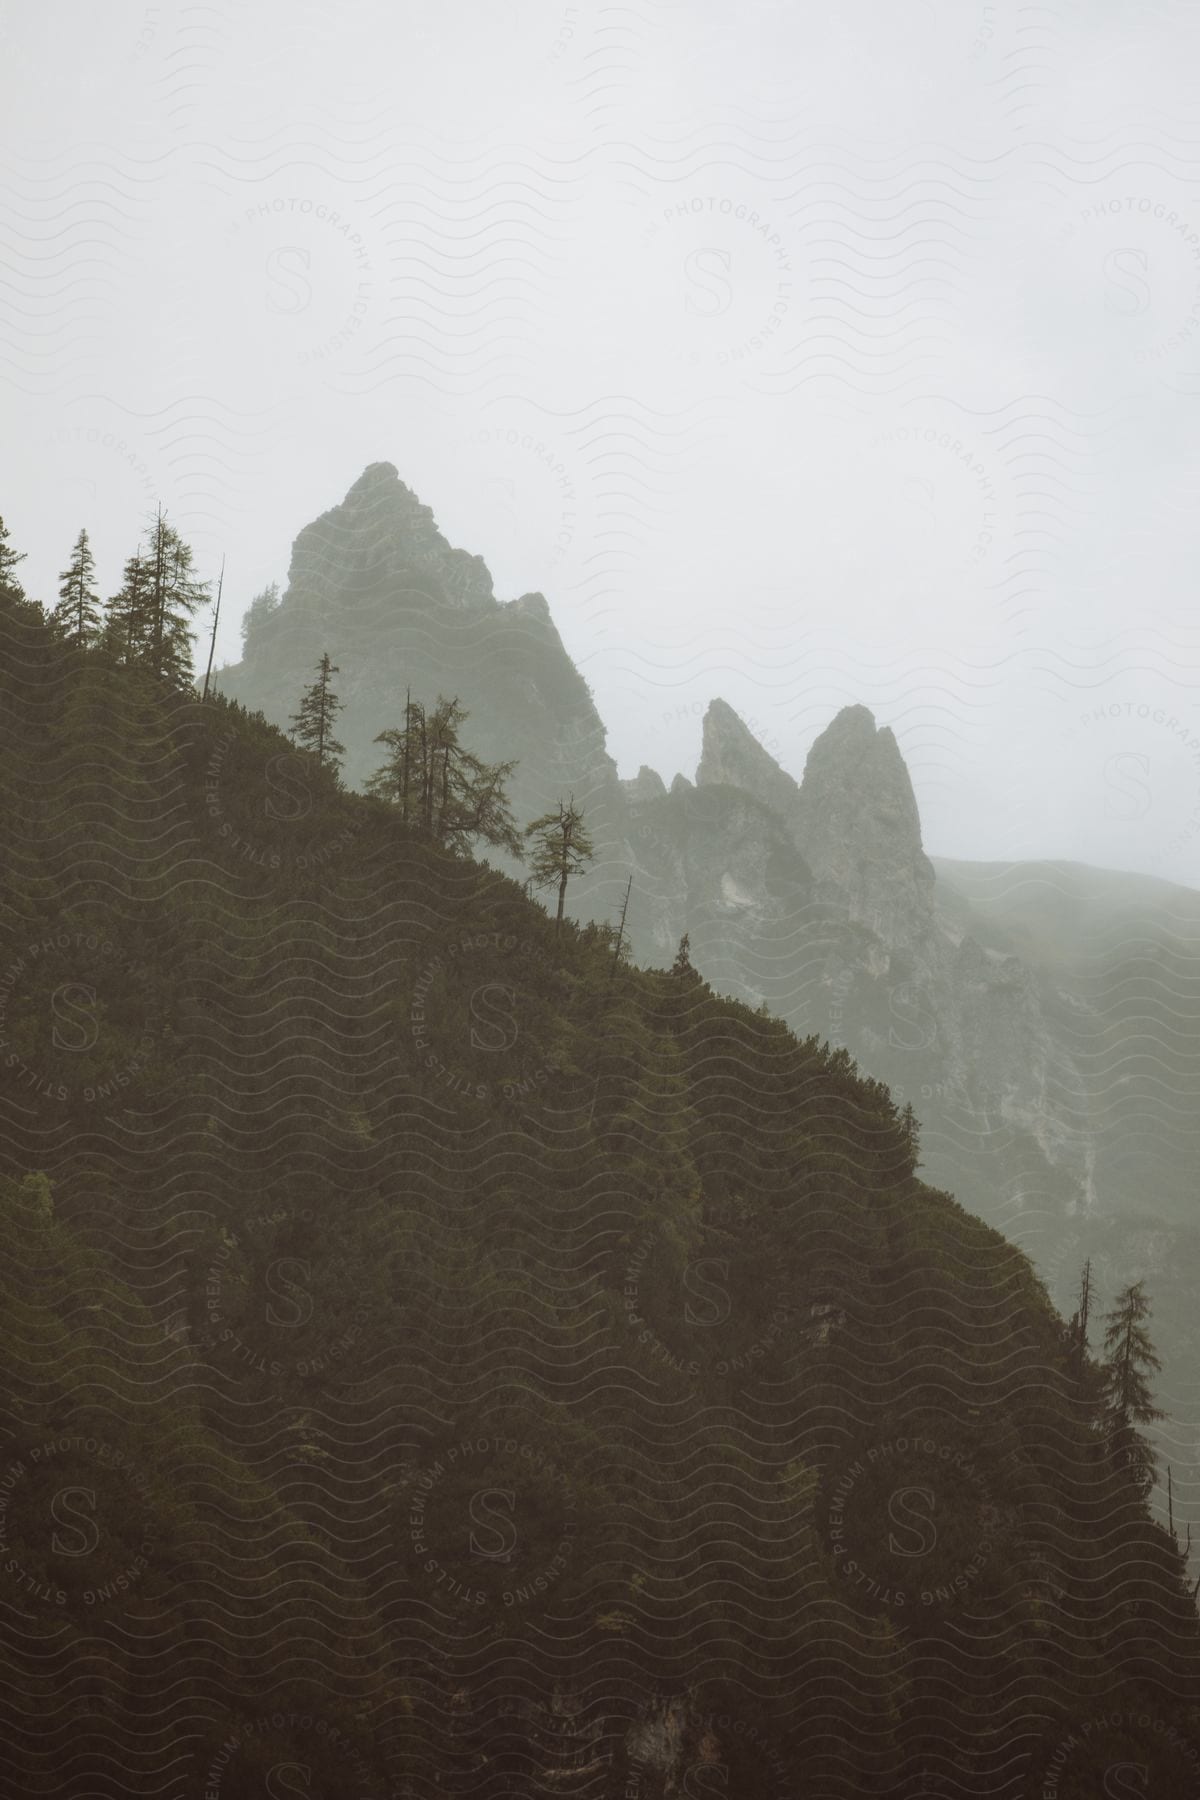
[689,700,1094,1228]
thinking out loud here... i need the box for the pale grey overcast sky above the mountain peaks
[0,0,1200,886]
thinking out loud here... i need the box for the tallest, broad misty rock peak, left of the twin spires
[218,463,624,916]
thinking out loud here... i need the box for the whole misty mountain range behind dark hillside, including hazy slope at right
[219,464,1200,1562]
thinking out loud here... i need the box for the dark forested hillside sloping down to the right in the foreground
[0,531,1200,1800]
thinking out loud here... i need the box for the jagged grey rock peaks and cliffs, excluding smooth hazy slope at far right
[221,463,1194,1260]
